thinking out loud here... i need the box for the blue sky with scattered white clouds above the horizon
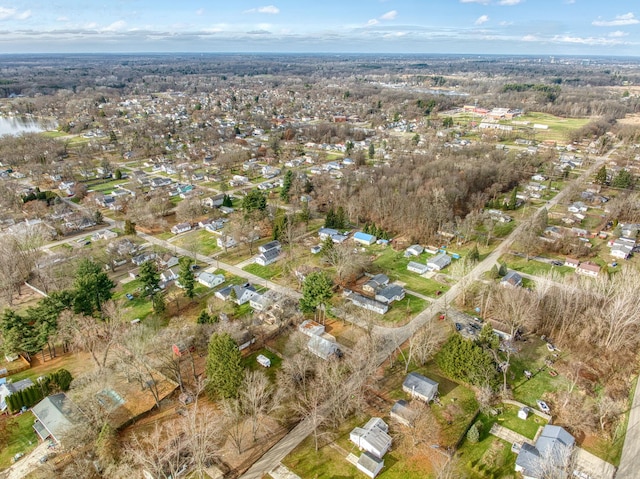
[0,0,640,55]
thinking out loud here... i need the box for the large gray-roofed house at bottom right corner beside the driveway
[516,425,576,479]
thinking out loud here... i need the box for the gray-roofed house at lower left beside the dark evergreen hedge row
[31,393,81,442]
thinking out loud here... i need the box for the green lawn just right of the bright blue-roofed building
[372,248,449,298]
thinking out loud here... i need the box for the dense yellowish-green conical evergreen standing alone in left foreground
[206,333,243,398]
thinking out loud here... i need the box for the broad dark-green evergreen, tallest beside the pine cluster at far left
[73,259,115,315]
